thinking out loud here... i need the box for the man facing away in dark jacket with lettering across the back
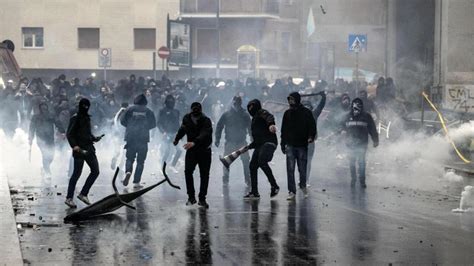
[120,94,156,187]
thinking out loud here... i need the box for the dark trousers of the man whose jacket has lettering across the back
[125,142,148,183]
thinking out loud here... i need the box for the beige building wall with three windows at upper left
[0,0,179,70]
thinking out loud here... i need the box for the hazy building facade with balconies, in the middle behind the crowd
[179,0,302,79]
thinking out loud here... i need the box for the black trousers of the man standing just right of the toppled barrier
[184,148,211,200]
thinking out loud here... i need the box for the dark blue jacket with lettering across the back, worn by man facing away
[120,105,156,143]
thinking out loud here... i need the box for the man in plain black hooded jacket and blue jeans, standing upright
[281,92,316,200]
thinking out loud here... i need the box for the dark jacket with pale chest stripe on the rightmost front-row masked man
[344,98,379,147]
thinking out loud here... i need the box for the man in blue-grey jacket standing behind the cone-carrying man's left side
[215,96,250,187]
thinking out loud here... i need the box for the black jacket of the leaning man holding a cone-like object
[249,109,278,149]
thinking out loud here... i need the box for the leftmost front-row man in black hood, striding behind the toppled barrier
[65,98,102,208]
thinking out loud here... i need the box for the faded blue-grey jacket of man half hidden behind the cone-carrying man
[216,108,250,143]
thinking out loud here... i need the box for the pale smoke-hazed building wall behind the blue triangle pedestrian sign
[301,0,388,79]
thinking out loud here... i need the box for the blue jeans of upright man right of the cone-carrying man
[286,145,308,193]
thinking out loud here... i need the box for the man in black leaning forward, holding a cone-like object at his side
[244,99,280,200]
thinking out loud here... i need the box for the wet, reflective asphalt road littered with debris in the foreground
[10,143,474,265]
